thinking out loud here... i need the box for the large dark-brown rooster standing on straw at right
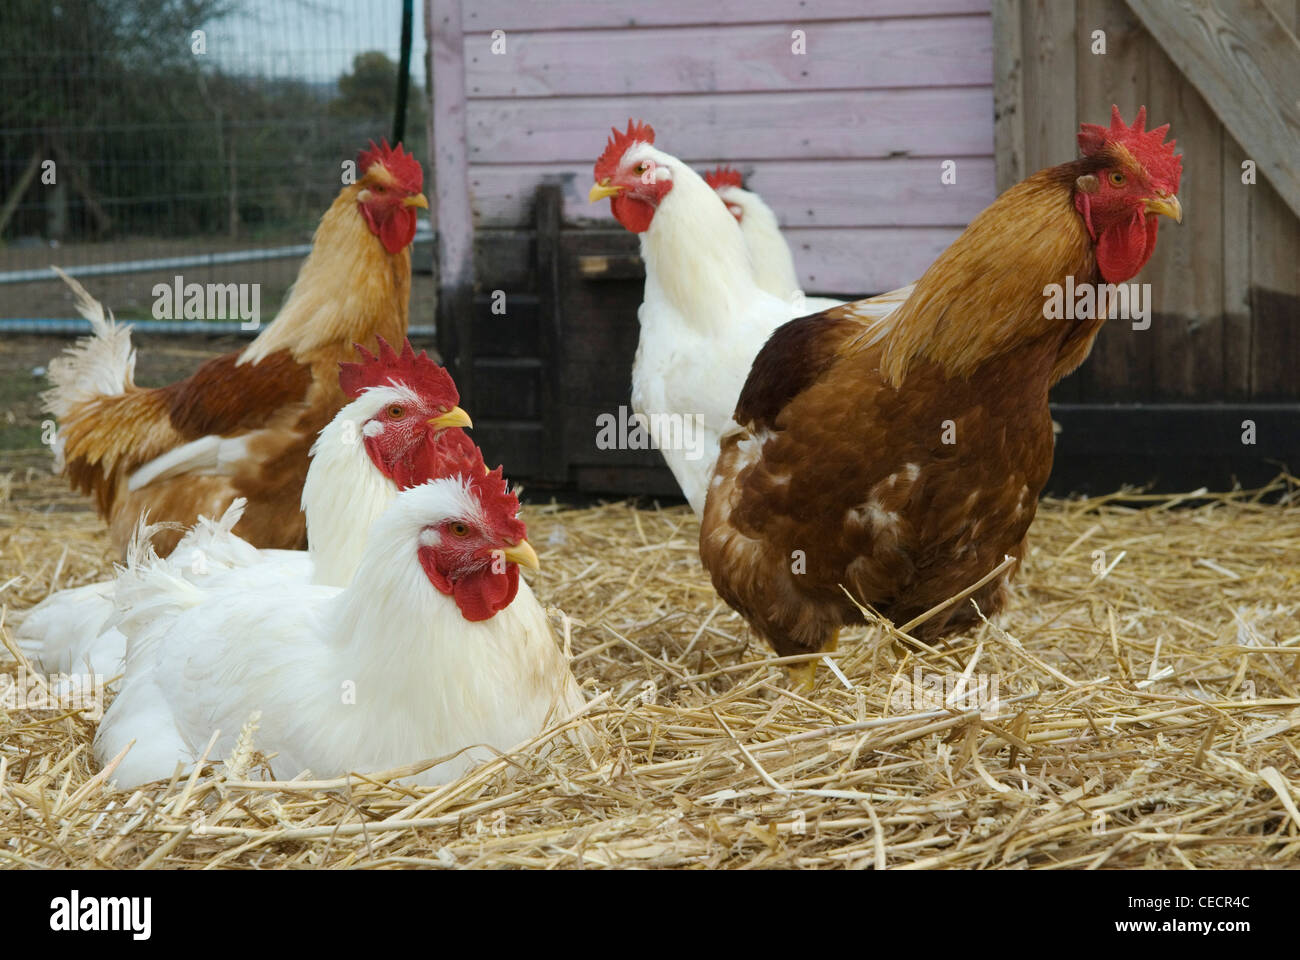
[699,108,1182,683]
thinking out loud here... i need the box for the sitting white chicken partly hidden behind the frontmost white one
[16,338,477,676]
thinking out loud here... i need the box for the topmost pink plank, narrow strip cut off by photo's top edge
[464,0,989,33]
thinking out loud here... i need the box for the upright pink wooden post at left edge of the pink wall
[424,0,475,415]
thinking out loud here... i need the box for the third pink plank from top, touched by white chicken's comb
[468,86,993,163]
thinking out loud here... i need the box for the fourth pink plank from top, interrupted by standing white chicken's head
[469,156,995,226]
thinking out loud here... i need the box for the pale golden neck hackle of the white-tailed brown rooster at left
[239,183,411,364]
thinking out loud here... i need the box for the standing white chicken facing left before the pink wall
[589,121,797,515]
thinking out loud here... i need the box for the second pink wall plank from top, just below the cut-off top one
[462,14,993,98]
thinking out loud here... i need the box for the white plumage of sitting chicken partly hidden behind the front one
[16,384,457,680]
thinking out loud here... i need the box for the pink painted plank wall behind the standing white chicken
[432,0,995,293]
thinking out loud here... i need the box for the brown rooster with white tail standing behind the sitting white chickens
[44,137,429,554]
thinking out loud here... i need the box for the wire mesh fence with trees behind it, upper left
[0,0,433,323]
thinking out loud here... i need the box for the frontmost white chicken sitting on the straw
[95,468,584,787]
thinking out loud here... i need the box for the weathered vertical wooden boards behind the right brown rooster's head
[995,0,1300,400]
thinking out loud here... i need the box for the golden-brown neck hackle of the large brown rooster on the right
[848,159,1100,386]
